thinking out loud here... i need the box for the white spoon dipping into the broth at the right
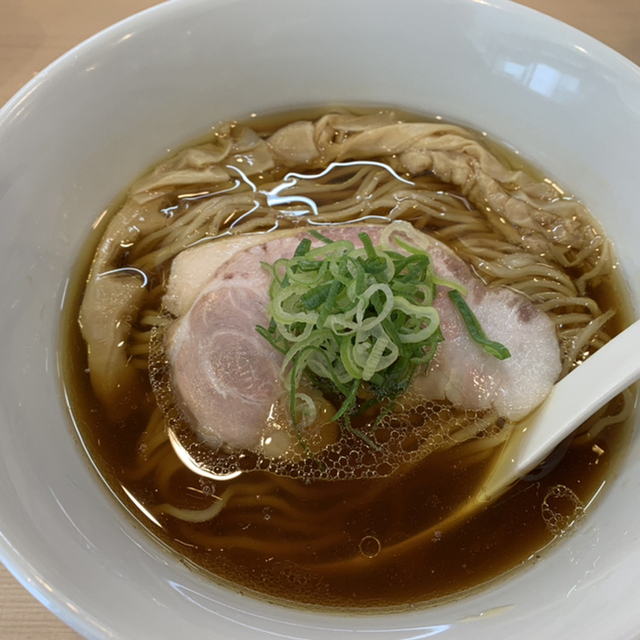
[477,320,640,502]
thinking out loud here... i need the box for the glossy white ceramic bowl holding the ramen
[0,0,640,640]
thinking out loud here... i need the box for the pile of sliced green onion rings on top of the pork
[256,230,510,444]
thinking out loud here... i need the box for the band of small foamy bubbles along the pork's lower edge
[149,330,504,482]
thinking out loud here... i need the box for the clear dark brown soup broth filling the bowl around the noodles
[61,109,629,609]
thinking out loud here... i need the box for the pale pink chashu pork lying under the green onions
[163,222,560,449]
